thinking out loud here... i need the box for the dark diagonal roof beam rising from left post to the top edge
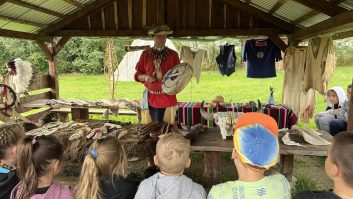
[39,0,112,35]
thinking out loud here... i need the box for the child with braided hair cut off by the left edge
[0,123,25,199]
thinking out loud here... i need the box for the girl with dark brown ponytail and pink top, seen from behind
[11,135,73,199]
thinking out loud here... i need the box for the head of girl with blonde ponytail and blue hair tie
[75,136,127,199]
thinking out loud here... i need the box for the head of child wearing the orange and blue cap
[233,113,279,170]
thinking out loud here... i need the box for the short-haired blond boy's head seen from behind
[156,133,190,174]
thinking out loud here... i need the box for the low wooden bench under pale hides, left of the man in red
[50,108,137,122]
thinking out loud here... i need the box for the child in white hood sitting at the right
[314,86,346,132]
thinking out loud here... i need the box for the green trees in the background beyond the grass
[0,37,353,74]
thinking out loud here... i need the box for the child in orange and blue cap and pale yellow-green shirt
[208,113,291,199]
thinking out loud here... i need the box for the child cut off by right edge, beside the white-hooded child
[329,85,352,135]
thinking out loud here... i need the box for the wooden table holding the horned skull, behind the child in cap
[191,128,332,187]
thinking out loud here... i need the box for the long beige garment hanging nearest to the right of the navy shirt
[282,47,316,122]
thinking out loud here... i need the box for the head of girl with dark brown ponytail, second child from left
[16,135,64,199]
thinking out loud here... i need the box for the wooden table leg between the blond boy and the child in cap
[203,151,221,188]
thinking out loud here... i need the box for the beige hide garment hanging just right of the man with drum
[180,46,208,83]
